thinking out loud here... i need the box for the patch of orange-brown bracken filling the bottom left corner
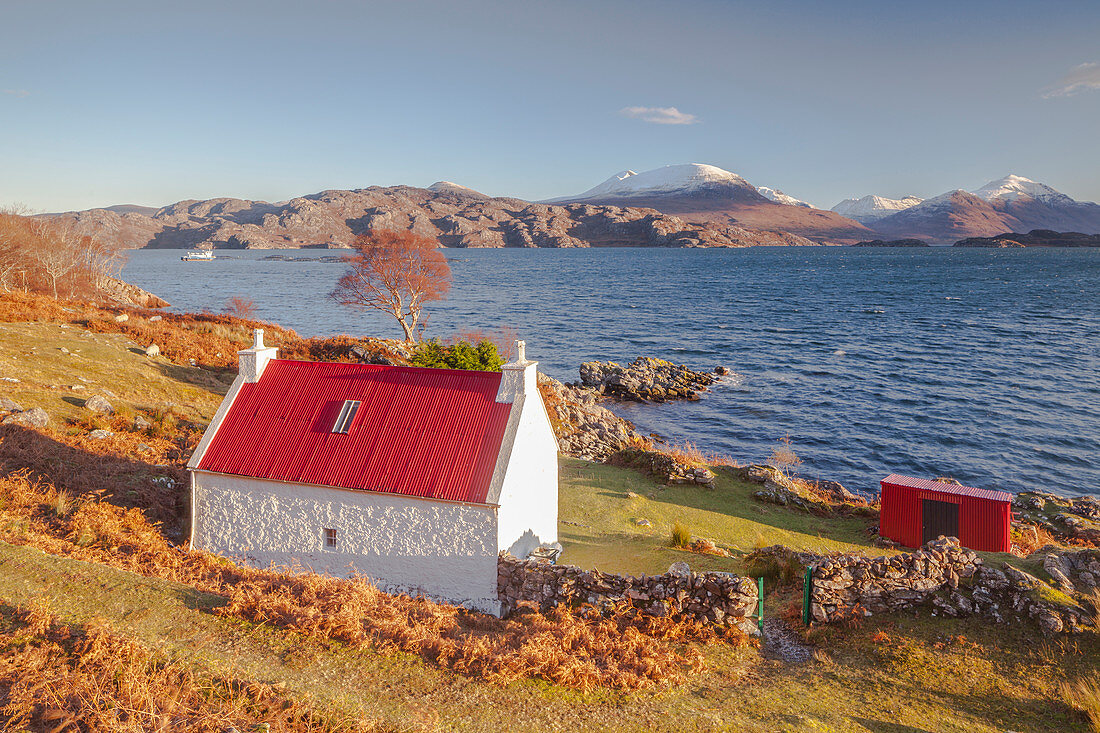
[0,603,380,733]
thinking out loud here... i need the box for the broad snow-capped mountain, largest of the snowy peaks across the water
[554,163,871,241]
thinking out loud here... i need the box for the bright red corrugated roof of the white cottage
[198,360,512,503]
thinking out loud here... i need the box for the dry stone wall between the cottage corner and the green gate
[497,554,758,633]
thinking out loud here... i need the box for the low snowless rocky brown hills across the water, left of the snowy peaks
[48,184,814,249]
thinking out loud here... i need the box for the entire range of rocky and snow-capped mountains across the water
[44,163,1100,249]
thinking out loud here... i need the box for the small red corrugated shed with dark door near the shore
[879,473,1012,553]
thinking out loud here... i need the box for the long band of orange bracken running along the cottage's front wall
[0,472,745,690]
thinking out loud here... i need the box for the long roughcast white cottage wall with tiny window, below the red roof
[193,471,499,613]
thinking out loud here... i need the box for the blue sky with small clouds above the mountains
[0,0,1100,211]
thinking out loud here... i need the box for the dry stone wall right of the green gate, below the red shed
[810,537,1088,634]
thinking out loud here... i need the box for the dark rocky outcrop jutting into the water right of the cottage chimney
[581,357,718,402]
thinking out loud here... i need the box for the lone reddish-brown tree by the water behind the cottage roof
[329,231,451,341]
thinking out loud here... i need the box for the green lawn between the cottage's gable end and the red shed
[558,458,886,575]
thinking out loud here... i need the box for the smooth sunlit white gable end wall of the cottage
[497,394,558,558]
